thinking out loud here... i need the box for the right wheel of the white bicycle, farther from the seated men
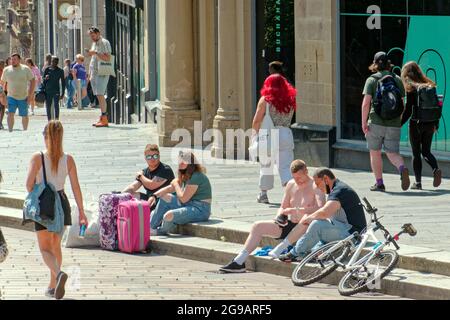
[338,250,399,296]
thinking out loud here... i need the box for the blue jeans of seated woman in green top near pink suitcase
[150,195,211,235]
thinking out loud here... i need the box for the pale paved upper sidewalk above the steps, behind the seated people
[0,109,450,250]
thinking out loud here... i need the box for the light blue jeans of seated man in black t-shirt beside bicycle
[291,220,352,257]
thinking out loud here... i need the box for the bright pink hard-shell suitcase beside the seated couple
[117,200,150,253]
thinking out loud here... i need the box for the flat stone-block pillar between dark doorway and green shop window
[295,0,337,126]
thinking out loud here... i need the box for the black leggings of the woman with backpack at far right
[409,121,439,182]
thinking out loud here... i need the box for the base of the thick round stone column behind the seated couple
[158,106,201,147]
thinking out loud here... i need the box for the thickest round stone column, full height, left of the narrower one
[158,0,201,147]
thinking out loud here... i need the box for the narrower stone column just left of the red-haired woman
[212,0,242,158]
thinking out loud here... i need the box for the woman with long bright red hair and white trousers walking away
[252,74,297,204]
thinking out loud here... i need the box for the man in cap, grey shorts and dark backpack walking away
[362,52,410,192]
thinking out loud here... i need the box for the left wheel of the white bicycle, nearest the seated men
[292,241,350,287]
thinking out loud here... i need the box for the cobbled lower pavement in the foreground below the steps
[0,228,399,300]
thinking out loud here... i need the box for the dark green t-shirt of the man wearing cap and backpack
[363,71,405,128]
